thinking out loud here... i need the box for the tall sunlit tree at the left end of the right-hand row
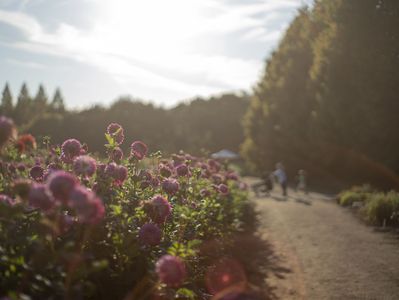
[243,8,318,170]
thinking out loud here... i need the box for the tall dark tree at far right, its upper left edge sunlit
[311,0,399,172]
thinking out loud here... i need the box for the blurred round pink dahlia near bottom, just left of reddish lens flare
[155,255,186,287]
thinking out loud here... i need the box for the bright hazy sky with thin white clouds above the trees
[0,0,310,108]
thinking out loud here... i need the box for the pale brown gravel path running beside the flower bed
[253,179,399,300]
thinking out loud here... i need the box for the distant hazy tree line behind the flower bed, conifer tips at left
[0,84,249,154]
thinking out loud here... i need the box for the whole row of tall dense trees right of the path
[242,0,399,188]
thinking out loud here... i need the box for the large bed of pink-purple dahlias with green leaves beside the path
[0,117,250,299]
